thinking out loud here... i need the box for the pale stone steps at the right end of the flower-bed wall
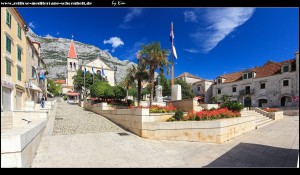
[241,110,274,129]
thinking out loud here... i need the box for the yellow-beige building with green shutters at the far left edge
[1,7,27,111]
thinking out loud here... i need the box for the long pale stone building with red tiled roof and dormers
[212,52,299,107]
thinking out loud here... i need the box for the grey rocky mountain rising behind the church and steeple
[27,29,136,83]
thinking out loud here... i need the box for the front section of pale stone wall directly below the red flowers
[142,117,255,143]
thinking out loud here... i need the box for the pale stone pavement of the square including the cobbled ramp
[32,99,299,168]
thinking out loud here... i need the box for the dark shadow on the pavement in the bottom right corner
[205,143,299,168]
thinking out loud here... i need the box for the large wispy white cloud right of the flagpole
[190,7,255,53]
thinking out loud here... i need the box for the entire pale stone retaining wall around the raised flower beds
[84,104,255,143]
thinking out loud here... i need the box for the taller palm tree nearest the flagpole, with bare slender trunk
[140,42,170,106]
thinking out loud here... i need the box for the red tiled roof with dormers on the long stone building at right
[218,59,295,83]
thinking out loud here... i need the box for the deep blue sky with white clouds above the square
[18,8,299,79]
